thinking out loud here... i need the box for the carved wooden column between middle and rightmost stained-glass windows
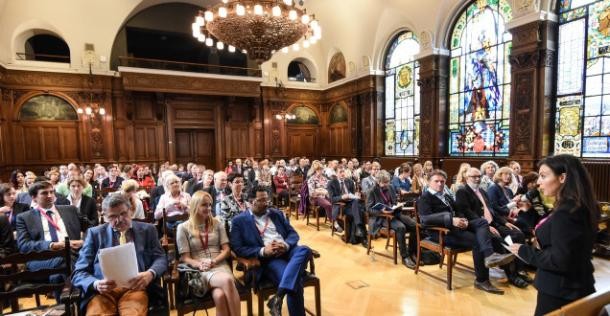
[509,21,556,170]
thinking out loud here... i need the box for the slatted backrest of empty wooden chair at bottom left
[0,237,72,312]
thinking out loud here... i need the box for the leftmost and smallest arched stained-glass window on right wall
[385,32,419,156]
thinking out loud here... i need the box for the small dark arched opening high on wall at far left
[24,34,70,63]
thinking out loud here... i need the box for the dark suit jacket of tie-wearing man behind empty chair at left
[17,205,81,253]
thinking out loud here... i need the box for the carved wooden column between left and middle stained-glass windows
[417,55,449,165]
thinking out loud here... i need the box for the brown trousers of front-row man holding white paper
[87,288,148,316]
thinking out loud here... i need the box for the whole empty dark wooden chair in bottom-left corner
[0,237,80,315]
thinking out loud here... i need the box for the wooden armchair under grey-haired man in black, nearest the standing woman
[413,203,472,290]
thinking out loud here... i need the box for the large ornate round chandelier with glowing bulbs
[192,0,322,64]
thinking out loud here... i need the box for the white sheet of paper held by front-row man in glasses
[99,243,138,287]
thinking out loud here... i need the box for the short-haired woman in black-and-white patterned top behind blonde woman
[216,173,251,229]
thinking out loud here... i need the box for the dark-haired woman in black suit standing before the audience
[511,155,599,315]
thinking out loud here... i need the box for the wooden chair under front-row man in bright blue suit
[237,249,322,316]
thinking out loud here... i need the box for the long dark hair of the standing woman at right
[538,155,599,231]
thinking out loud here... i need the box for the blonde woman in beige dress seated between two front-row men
[176,191,241,316]
